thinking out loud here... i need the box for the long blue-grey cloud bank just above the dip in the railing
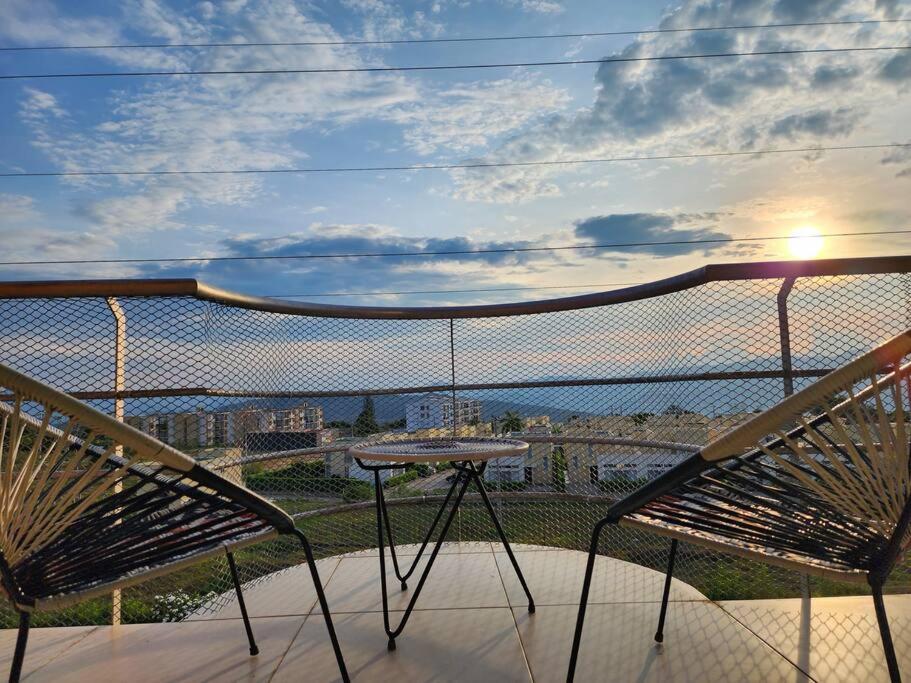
[129,223,575,303]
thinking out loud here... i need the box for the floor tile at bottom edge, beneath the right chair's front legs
[514,602,805,683]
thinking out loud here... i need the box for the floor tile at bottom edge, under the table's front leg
[273,608,531,683]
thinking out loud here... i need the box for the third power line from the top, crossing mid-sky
[0,142,911,178]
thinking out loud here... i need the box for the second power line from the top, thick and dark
[0,45,911,81]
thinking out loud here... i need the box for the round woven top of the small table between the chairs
[348,436,528,462]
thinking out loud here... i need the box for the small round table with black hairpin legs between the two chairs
[348,437,535,650]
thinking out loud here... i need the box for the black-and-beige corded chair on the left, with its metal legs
[0,364,348,681]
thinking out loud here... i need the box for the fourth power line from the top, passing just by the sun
[0,229,911,266]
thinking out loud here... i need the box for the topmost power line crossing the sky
[0,19,911,52]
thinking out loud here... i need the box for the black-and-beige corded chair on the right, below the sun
[567,331,911,681]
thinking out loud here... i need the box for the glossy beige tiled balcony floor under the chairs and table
[0,543,911,683]
